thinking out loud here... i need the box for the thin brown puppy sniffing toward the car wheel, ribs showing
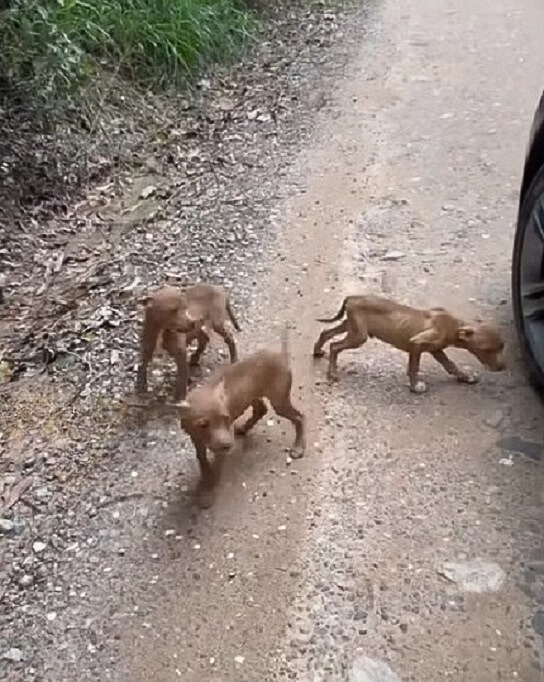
[313,294,506,393]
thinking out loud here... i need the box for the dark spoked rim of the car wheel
[520,185,544,367]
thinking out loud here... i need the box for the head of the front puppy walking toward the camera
[177,381,234,455]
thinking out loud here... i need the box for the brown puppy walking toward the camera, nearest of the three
[172,332,306,501]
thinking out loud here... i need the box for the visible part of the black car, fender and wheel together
[512,92,544,389]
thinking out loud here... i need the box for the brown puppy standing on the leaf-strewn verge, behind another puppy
[136,284,240,401]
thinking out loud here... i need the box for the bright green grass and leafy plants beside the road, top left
[0,0,254,102]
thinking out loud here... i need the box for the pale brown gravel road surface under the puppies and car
[0,0,544,682]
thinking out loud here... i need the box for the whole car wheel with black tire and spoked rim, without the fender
[512,165,544,391]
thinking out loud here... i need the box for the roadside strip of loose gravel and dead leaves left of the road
[0,2,366,682]
